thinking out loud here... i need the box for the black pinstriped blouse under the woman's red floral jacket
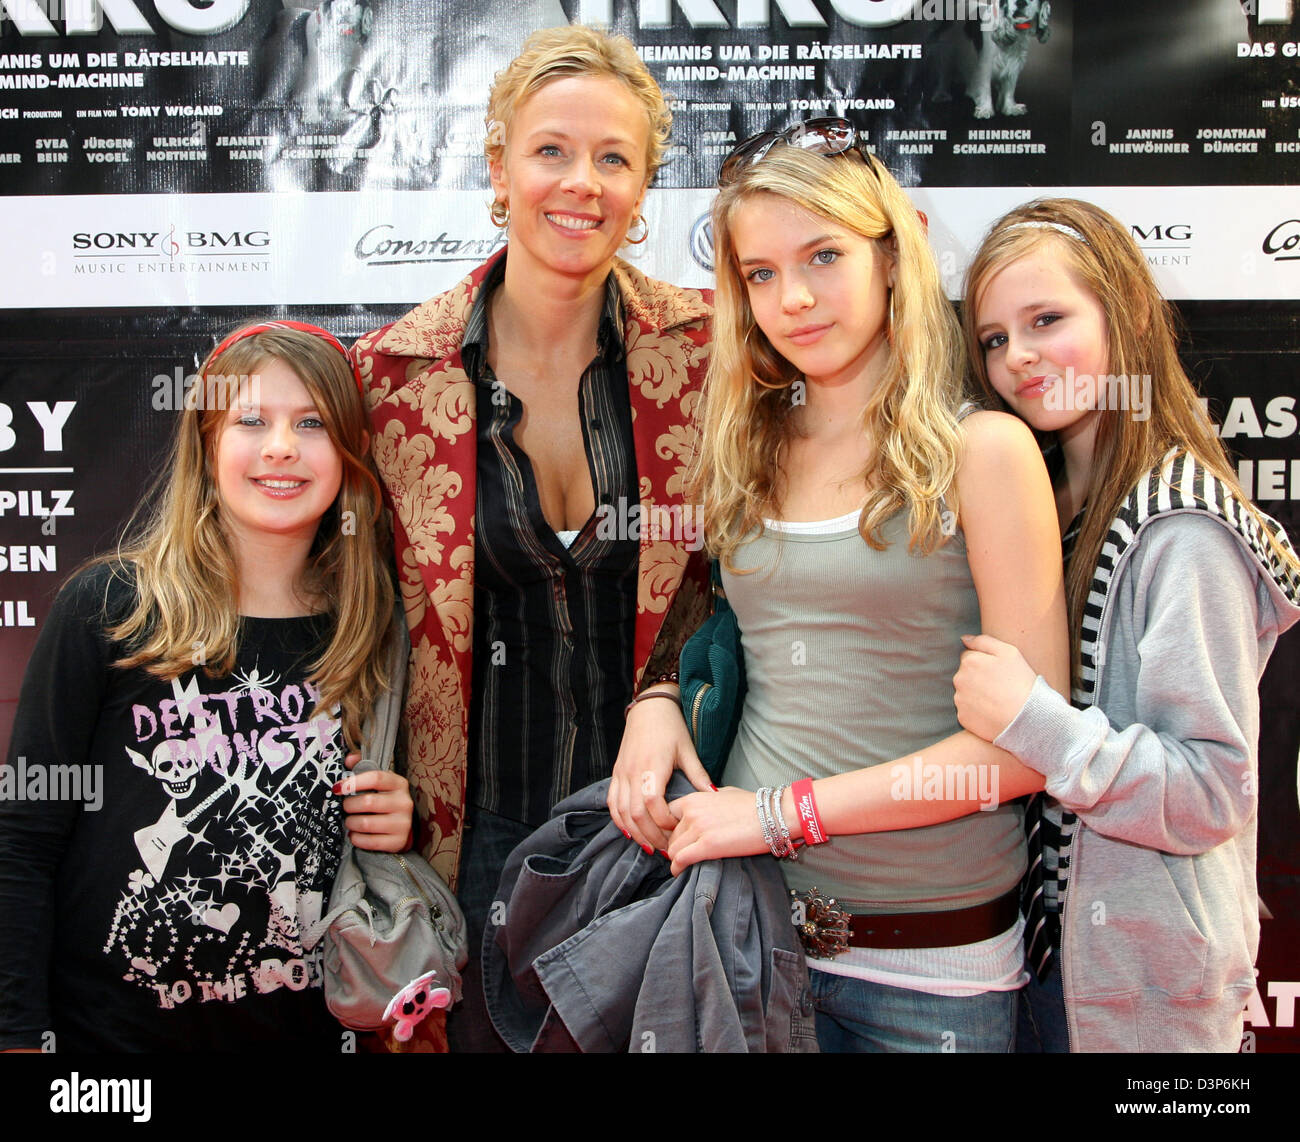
[462,260,638,825]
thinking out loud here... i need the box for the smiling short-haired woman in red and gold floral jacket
[355,26,710,1050]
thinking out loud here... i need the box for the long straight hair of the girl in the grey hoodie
[962,199,1296,674]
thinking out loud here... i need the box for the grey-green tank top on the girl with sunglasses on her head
[723,511,1024,913]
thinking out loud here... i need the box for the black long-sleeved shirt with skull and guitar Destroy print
[0,567,346,1051]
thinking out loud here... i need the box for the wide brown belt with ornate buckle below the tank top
[790,887,1021,959]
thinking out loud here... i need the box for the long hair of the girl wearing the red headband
[98,328,394,747]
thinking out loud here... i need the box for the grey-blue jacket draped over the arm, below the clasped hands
[484,774,816,1052]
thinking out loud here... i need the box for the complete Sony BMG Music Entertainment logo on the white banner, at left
[72,222,272,276]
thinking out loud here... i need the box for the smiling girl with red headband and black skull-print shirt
[0,321,413,1051]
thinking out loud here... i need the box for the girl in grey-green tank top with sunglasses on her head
[615,127,1066,1051]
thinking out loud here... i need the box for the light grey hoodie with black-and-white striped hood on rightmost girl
[996,457,1300,1051]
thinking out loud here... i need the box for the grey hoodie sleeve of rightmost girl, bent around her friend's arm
[995,515,1279,855]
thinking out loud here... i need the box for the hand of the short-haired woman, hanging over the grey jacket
[606,689,712,852]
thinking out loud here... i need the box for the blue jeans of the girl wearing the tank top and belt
[809,969,1018,1054]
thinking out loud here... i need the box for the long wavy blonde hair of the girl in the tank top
[689,146,963,567]
